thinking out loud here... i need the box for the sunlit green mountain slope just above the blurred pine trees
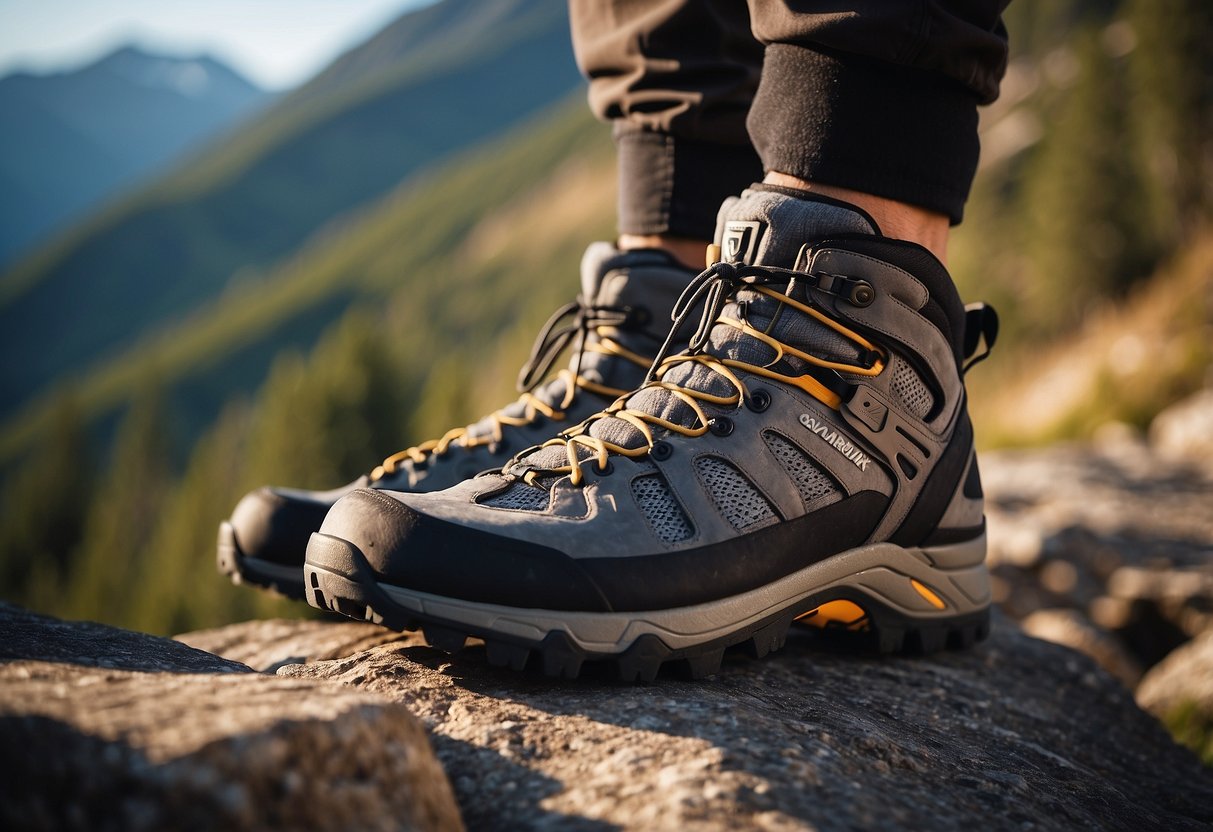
[0,95,613,465]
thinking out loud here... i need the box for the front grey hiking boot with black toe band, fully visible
[304,186,995,680]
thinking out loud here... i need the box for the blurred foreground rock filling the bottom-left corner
[0,605,460,831]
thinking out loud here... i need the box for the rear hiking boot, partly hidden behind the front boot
[218,243,695,599]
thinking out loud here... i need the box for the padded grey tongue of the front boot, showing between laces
[524,186,879,468]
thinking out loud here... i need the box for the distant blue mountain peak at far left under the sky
[0,46,265,266]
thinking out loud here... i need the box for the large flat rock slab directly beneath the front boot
[280,620,1213,830]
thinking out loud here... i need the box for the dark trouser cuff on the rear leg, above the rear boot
[615,125,762,240]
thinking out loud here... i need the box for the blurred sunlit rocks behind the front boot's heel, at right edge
[983,389,1213,765]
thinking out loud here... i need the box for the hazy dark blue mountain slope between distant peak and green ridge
[0,0,580,424]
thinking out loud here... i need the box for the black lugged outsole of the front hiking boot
[303,535,990,683]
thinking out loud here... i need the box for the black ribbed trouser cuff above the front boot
[746,44,979,224]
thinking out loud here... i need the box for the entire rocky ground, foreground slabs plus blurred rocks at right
[0,394,1213,830]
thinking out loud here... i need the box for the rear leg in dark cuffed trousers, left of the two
[570,0,762,269]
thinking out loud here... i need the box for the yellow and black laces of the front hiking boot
[507,263,885,485]
